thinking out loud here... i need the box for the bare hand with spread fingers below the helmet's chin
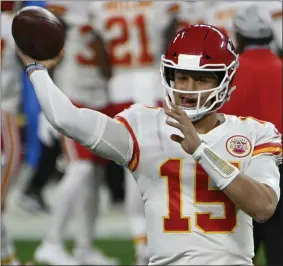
[165,103,201,154]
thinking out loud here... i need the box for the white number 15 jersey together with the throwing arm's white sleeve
[30,67,282,265]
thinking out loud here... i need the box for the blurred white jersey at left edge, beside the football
[1,12,21,114]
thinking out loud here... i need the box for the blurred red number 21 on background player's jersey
[105,15,153,67]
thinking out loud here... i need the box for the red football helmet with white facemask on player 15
[160,24,239,121]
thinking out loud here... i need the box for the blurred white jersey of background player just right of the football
[49,1,108,109]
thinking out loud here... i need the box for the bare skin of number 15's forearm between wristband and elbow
[223,174,277,222]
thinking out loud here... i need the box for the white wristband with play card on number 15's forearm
[192,143,240,190]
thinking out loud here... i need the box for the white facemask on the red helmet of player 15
[160,56,238,122]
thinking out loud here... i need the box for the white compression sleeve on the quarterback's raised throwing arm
[30,70,133,165]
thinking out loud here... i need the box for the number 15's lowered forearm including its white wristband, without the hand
[193,144,277,221]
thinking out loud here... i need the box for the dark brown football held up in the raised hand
[12,6,65,60]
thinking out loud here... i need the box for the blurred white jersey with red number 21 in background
[90,1,185,105]
